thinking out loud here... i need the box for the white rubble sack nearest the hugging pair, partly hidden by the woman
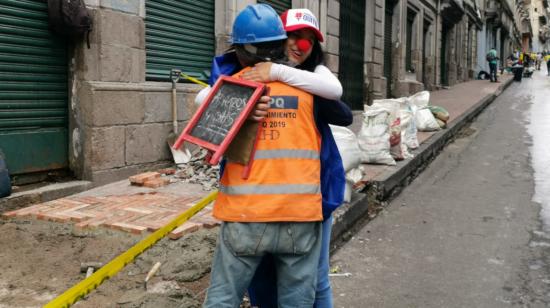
[329,125,361,172]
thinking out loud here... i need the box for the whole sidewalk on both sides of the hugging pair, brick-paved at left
[0,75,512,240]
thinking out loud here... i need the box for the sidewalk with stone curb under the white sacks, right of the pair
[332,74,513,242]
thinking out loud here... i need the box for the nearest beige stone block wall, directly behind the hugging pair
[69,0,340,185]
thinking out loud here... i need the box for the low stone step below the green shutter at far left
[0,181,92,213]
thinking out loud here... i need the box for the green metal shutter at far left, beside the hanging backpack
[0,0,68,174]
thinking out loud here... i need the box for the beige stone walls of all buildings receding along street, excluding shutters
[69,0,508,185]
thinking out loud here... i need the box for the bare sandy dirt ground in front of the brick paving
[0,220,218,308]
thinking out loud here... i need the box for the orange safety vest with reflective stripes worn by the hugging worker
[213,69,323,222]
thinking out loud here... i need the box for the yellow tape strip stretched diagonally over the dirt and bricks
[44,191,218,308]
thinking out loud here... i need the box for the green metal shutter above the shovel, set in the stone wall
[145,0,215,81]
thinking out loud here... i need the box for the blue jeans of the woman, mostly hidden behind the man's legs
[248,216,333,308]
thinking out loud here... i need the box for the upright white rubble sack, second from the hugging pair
[357,106,395,165]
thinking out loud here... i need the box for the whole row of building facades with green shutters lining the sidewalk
[0,0,528,185]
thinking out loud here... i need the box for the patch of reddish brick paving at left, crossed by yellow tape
[2,192,219,239]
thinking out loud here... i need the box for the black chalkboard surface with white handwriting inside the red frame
[190,83,255,145]
